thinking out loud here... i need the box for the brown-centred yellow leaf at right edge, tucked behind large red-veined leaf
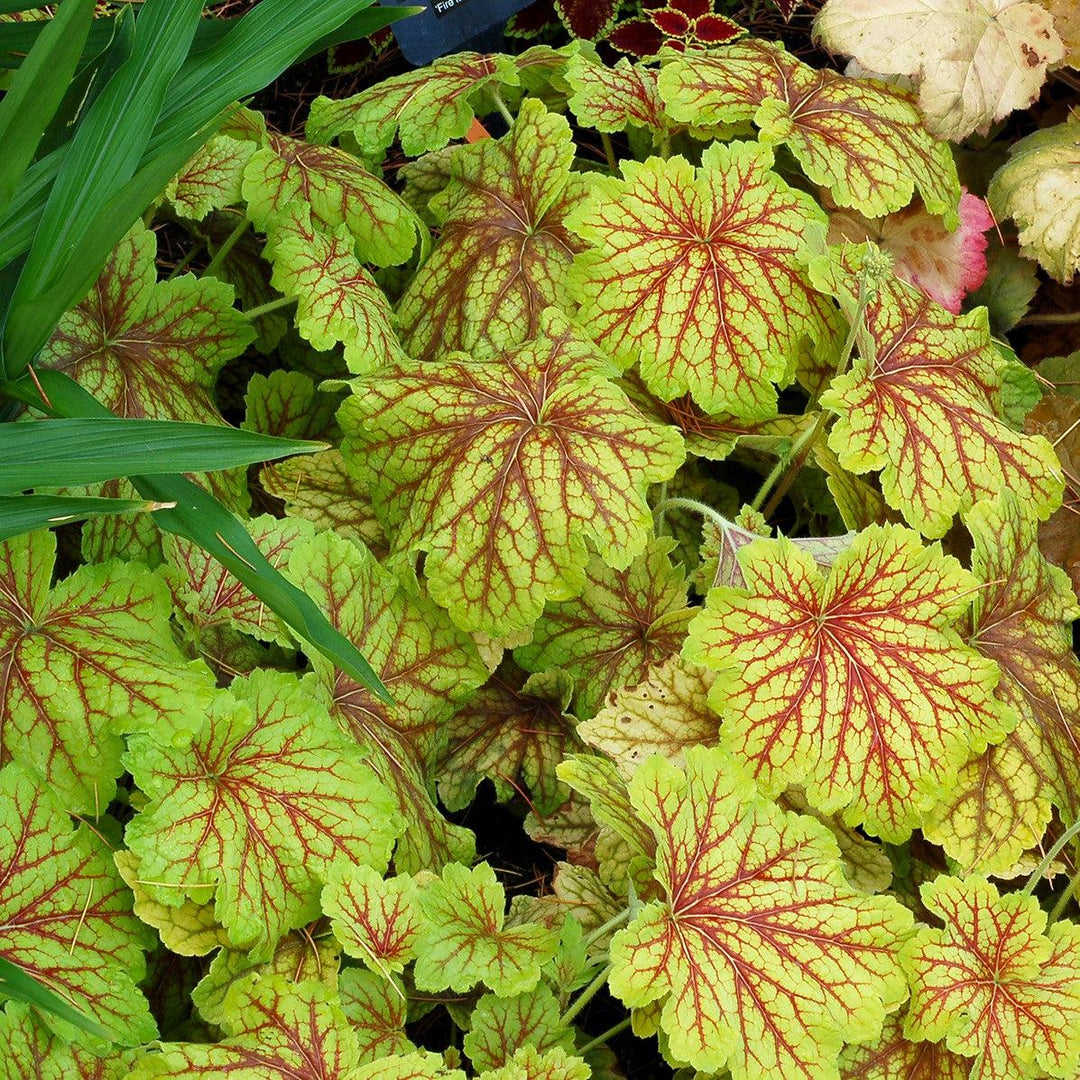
[923,494,1080,873]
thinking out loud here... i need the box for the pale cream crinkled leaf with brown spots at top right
[814,0,1065,140]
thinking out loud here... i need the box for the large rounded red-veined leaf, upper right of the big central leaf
[569,136,837,420]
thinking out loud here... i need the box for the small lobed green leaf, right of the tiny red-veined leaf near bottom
[414,863,558,997]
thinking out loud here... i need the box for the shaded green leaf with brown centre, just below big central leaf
[514,538,693,717]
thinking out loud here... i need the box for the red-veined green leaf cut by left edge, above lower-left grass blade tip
[0,764,157,1047]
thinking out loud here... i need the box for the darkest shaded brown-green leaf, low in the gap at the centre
[436,663,581,814]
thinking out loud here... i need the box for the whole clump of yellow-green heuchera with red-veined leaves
[0,10,1080,1080]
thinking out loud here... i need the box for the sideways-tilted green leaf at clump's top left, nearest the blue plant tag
[307,53,517,158]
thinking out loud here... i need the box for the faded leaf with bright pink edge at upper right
[828,191,994,315]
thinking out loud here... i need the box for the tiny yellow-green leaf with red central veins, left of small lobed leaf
[322,863,423,977]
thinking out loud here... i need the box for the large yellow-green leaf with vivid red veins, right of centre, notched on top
[684,526,1015,841]
